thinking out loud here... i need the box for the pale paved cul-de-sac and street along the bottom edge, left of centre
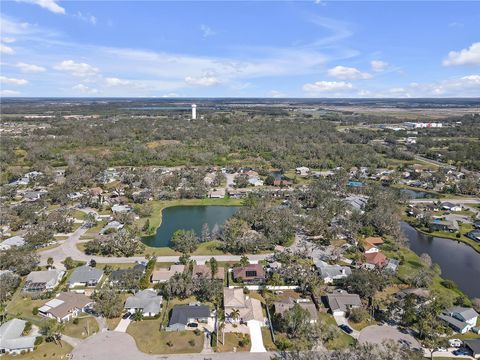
[72,331,274,360]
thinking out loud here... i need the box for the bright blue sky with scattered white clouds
[0,0,480,98]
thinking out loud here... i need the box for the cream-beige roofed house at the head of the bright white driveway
[223,288,264,326]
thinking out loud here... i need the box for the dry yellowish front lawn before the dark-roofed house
[127,319,204,354]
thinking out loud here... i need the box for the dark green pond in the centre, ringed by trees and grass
[143,205,239,247]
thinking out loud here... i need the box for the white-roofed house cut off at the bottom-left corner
[0,319,36,355]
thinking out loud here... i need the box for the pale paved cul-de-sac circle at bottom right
[358,325,421,349]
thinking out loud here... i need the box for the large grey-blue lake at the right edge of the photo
[401,222,480,297]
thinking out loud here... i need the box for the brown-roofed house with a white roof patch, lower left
[38,292,93,322]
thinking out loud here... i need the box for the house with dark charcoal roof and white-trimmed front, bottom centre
[165,304,213,331]
